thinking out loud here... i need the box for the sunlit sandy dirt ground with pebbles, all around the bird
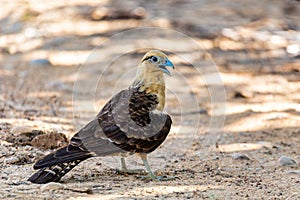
[0,0,300,199]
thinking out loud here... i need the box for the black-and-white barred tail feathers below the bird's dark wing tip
[28,159,85,184]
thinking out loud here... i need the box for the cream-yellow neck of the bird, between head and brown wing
[132,72,165,111]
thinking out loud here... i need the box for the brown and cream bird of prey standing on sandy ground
[28,49,175,184]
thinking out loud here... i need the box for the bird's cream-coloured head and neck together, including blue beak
[133,50,174,110]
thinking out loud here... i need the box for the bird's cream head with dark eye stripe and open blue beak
[139,50,174,75]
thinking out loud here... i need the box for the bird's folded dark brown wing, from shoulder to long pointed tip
[34,89,172,169]
